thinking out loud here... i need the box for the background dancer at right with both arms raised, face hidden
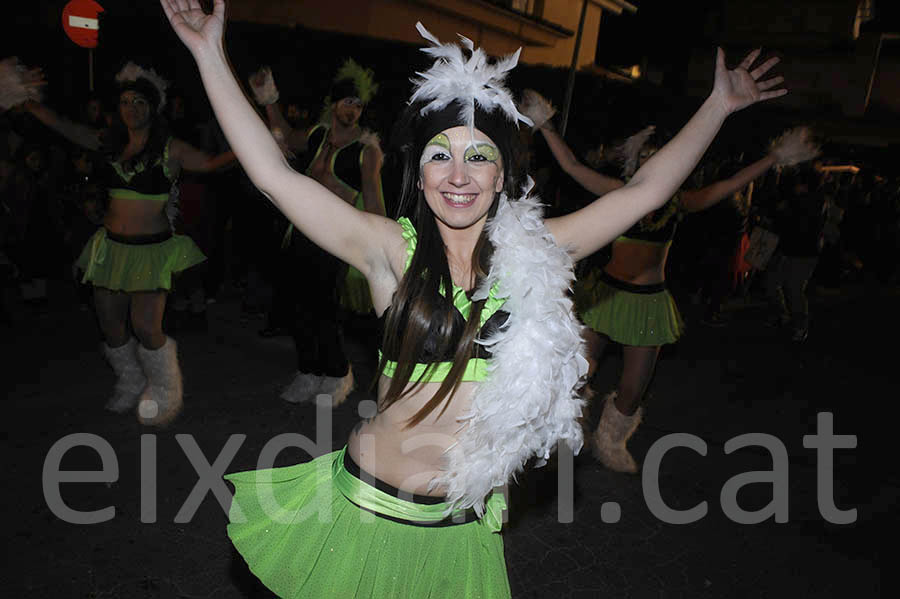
[520,90,818,472]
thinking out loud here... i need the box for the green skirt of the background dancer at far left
[75,228,206,292]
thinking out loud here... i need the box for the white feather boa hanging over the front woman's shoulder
[431,184,588,515]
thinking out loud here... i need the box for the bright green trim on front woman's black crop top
[378,217,509,383]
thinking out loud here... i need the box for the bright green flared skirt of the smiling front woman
[225,449,510,599]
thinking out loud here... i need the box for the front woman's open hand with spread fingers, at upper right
[711,48,787,113]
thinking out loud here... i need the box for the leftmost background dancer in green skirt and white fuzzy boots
[25,63,234,425]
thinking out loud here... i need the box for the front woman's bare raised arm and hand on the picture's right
[547,48,787,259]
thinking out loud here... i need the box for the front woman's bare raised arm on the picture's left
[160,0,402,276]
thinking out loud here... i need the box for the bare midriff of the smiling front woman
[347,376,480,497]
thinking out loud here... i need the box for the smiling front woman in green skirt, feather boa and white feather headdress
[162,0,786,598]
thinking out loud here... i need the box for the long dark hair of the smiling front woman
[378,103,524,427]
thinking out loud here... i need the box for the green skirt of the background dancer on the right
[575,271,685,347]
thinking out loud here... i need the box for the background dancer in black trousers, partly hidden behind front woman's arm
[250,59,385,405]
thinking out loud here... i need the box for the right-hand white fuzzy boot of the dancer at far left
[137,337,182,426]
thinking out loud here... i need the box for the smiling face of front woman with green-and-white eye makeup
[419,126,503,229]
